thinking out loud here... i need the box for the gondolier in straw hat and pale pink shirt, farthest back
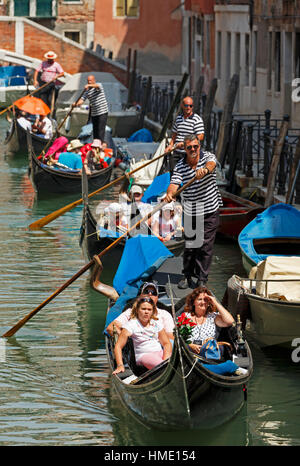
[33,51,64,108]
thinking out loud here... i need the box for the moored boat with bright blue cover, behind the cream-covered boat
[238,203,300,274]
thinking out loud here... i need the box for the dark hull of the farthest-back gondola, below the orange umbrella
[4,116,49,155]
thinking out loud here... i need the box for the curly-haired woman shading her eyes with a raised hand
[184,286,234,354]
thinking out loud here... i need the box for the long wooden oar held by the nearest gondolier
[2,176,197,338]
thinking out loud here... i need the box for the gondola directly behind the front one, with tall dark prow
[79,167,184,267]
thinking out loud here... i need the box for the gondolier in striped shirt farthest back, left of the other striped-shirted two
[73,74,108,142]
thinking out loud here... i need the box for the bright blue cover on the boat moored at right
[238,203,300,264]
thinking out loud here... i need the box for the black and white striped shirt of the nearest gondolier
[171,151,223,215]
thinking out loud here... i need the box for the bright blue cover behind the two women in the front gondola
[105,235,173,328]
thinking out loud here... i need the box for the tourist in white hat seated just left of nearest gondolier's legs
[152,202,182,242]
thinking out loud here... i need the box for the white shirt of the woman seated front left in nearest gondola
[124,319,163,361]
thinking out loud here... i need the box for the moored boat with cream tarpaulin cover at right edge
[224,256,300,350]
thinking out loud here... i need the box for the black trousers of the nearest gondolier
[183,210,219,283]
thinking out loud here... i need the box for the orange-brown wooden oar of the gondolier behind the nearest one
[29,141,176,230]
